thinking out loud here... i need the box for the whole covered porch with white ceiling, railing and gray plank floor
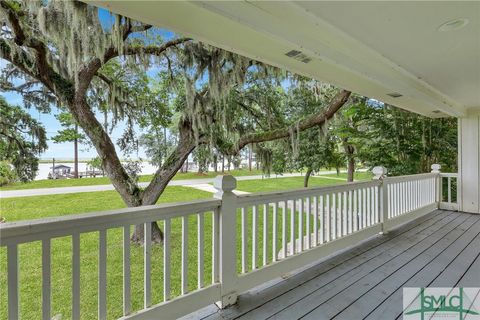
[0,1,480,319]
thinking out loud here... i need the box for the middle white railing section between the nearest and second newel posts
[232,180,382,292]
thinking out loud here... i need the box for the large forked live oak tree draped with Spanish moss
[0,0,350,243]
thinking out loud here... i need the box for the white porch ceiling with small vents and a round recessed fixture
[87,1,480,117]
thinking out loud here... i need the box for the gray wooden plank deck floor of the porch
[185,210,480,320]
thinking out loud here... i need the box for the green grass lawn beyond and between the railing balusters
[0,175,372,320]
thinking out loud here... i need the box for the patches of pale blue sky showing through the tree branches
[0,9,174,160]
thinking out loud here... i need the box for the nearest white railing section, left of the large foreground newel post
[0,199,221,319]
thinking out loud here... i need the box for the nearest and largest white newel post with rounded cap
[213,175,238,308]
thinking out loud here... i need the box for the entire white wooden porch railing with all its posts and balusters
[0,167,456,319]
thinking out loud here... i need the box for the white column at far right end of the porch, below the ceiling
[458,115,480,213]
